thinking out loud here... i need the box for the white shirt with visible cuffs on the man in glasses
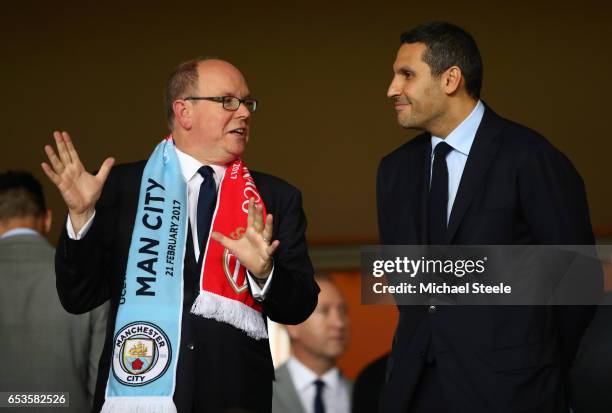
[66,148,274,300]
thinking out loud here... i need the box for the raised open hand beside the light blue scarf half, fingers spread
[41,131,115,233]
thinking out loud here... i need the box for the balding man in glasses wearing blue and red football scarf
[43,59,318,412]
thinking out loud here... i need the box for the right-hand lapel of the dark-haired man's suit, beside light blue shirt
[447,107,501,244]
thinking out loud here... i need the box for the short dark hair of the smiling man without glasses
[400,22,483,99]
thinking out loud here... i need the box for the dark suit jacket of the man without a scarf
[377,108,594,413]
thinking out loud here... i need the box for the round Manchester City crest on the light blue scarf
[113,321,172,386]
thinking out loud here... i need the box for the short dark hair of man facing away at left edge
[0,171,47,221]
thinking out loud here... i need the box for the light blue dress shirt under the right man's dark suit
[429,100,485,223]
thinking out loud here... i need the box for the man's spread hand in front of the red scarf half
[211,198,280,279]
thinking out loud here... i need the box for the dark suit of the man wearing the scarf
[56,161,318,412]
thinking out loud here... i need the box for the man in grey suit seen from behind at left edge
[0,171,107,412]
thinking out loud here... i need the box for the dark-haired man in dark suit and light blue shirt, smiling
[377,22,594,413]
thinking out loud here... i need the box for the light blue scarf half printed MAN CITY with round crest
[102,137,188,413]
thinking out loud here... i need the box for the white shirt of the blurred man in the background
[287,356,351,413]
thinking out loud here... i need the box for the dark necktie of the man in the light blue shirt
[428,142,453,245]
